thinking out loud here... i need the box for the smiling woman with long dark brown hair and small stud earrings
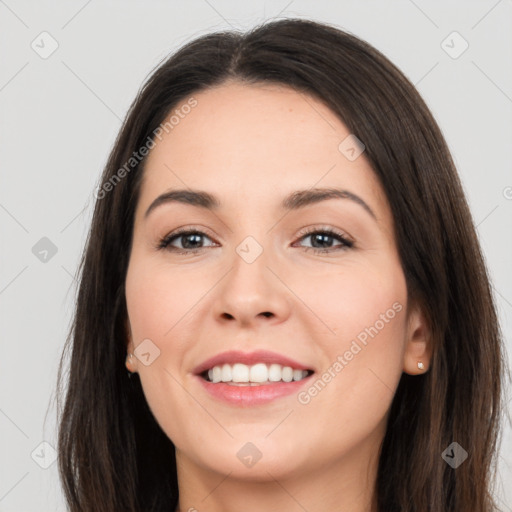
[59,19,503,512]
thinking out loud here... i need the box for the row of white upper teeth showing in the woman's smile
[208,363,308,384]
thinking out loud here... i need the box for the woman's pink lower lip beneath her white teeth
[196,374,314,407]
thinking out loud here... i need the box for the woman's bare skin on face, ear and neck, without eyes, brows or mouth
[126,82,431,512]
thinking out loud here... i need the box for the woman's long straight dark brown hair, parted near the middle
[57,19,504,512]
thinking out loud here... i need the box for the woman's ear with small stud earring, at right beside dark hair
[403,305,432,375]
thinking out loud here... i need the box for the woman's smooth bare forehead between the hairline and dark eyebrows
[141,82,385,220]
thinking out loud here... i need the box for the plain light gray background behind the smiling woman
[0,0,512,512]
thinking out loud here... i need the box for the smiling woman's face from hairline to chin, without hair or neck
[126,83,426,480]
